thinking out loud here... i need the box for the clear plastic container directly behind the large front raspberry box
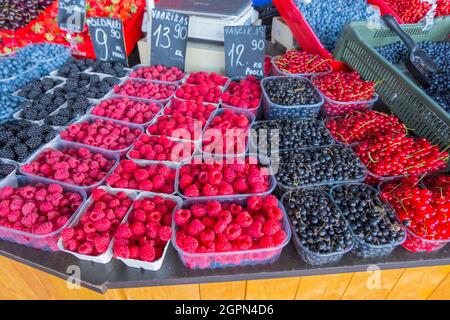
[176,154,277,201]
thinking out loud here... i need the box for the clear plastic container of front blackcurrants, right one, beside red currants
[330,183,406,258]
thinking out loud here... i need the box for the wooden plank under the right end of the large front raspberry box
[245,277,300,300]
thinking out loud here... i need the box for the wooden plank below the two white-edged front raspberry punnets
[123,284,200,300]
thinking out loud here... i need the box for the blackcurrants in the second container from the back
[251,119,334,155]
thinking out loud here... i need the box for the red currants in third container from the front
[325,110,407,144]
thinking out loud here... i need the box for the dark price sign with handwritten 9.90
[87,18,128,65]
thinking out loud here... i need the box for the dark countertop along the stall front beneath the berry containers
[0,241,450,293]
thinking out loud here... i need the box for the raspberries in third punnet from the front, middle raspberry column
[128,134,195,163]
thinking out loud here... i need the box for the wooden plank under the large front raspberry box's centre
[200,281,246,300]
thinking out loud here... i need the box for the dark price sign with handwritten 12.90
[224,26,266,77]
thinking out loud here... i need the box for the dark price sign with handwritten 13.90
[151,9,189,70]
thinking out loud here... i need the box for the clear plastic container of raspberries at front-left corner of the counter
[0,175,86,251]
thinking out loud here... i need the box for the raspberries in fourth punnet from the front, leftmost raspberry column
[91,97,161,124]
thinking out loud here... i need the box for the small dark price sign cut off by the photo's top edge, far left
[58,0,86,32]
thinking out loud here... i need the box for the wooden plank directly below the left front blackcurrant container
[295,273,353,300]
